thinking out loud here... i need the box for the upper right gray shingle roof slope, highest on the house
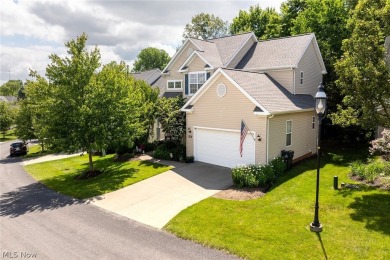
[236,34,314,70]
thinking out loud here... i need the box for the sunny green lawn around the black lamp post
[165,149,390,259]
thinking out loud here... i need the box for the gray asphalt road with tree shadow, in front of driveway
[0,143,236,259]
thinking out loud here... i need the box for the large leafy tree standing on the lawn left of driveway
[26,34,157,174]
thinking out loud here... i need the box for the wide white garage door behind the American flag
[194,128,255,168]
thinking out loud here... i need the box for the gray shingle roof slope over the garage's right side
[223,69,314,113]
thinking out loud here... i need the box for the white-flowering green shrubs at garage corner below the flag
[232,157,286,188]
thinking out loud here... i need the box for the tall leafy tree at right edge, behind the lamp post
[332,0,390,129]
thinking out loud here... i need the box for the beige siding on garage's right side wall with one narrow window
[268,112,317,160]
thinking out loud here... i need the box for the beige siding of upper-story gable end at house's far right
[295,40,322,96]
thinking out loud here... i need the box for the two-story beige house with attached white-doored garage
[161,33,326,167]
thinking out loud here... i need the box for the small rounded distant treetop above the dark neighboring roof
[133,47,171,72]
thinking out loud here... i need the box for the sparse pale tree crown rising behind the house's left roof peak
[183,13,229,40]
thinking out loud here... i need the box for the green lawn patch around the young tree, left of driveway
[25,155,172,199]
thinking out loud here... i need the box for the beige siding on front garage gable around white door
[186,75,266,163]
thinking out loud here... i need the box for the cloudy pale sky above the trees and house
[0,0,283,84]
